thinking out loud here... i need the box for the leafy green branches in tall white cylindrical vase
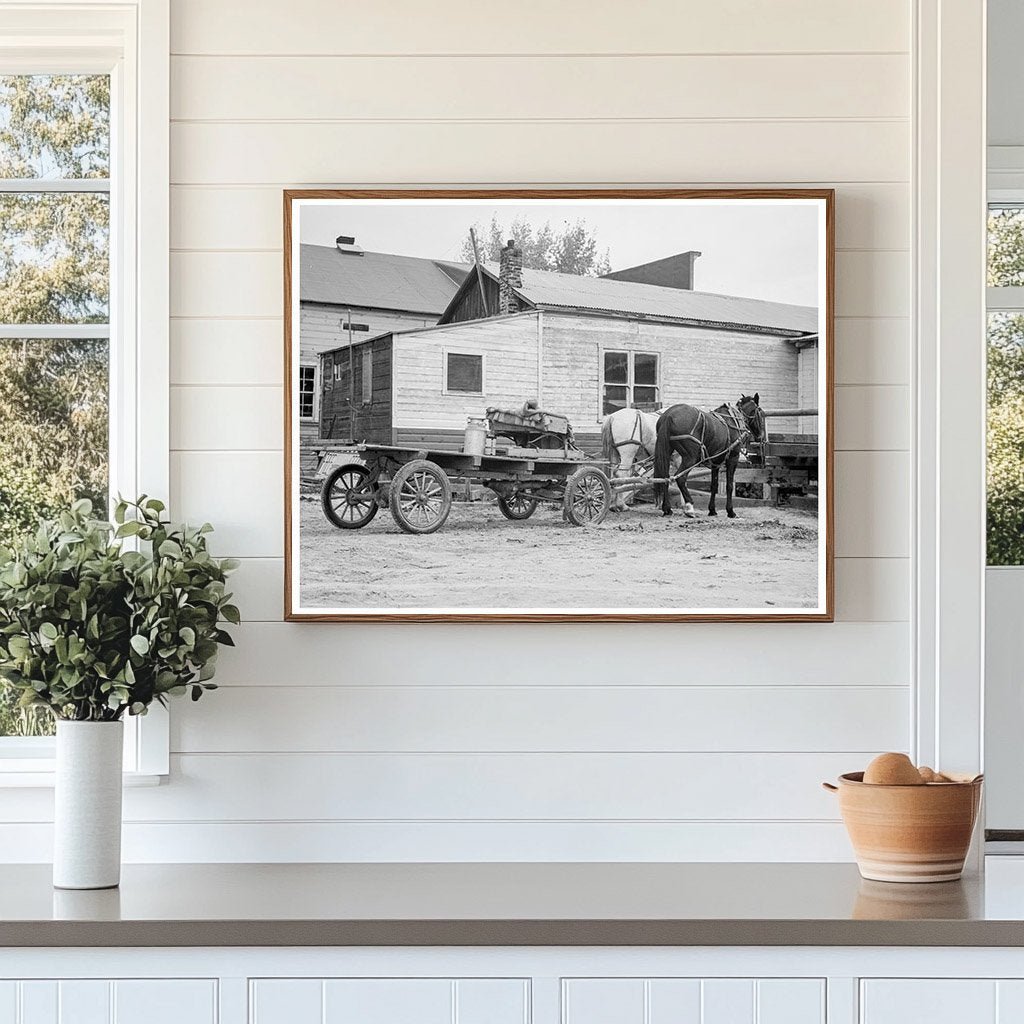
[0,496,239,889]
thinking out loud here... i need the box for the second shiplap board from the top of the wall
[171,53,910,121]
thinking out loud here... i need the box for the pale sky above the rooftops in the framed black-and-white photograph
[299,200,818,306]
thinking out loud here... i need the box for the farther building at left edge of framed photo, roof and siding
[296,236,469,442]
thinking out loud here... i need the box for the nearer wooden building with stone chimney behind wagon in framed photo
[321,241,818,450]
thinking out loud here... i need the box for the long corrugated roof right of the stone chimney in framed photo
[486,263,818,334]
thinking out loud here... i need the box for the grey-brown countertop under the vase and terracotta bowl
[6,858,1024,946]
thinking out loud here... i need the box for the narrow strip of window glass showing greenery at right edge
[987,204,1024,565]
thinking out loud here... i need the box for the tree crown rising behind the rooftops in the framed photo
[462,216,611,278]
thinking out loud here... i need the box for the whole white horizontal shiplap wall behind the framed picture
[4,0,911,860]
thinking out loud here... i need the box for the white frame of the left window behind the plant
[0,0,172,786]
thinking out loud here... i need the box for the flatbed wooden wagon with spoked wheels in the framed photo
[321,404,612,534]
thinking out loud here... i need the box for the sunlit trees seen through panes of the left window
[0,75,110,735]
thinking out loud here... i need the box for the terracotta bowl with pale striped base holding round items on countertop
[823,771,982,882]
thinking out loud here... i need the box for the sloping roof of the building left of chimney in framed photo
[299,244,469,315]
